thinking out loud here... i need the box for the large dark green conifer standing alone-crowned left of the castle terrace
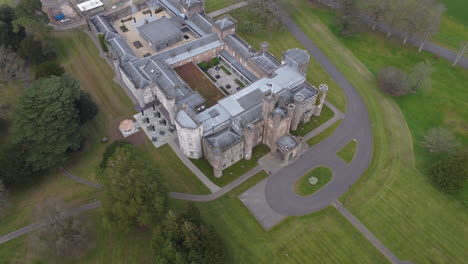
[12,75,81,171]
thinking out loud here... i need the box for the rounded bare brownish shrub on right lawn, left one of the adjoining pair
[377,67,411,96]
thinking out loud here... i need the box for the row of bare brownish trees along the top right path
[338,0,445,49]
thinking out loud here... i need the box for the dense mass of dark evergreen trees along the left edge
[0,0,98,188]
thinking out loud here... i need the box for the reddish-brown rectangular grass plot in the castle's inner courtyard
[175,63,224,107]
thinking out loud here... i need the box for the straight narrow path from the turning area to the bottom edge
[333,201,411,264]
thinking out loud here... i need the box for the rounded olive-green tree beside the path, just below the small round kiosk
[99,145,167,231]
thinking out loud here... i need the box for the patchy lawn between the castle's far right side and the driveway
[229,6,346,112]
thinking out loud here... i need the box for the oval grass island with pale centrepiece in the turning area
[294,167,333,196]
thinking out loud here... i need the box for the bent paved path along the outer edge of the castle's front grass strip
[170,166,263,202]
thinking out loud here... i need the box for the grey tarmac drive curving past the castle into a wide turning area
[265,16,373,216]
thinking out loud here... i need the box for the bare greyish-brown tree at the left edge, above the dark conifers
[0,46,29,81]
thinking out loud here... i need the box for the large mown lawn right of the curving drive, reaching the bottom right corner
[288,0,468,263]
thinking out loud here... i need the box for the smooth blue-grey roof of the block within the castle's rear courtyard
[138,17,182,46]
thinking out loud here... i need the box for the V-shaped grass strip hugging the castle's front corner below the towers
[191,145,270,187]
